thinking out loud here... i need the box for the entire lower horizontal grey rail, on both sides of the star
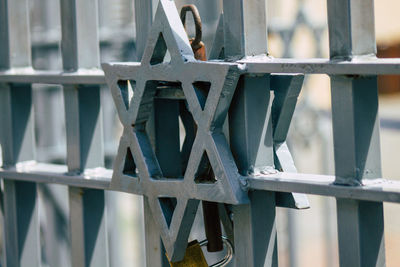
[0,161,400,203]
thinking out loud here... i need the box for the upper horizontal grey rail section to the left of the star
[0,68,106,84]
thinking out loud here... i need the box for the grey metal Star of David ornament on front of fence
[103,0,248,261]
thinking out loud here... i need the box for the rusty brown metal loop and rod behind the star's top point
[181,5,207,61]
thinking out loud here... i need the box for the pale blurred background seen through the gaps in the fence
[3,0,400,267]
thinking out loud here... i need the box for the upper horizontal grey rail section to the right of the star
[238,56,400,75]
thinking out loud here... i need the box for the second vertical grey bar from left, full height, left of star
[61,0,109,266]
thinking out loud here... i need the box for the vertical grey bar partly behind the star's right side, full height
[223,0,277,267]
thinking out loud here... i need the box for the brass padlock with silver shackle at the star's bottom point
[167,236,233,267]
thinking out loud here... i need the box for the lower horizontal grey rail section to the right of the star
[247,172,400,203]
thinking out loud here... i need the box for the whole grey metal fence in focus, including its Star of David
[0,0,400,267]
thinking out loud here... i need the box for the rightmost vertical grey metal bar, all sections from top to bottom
[328,0,385,266]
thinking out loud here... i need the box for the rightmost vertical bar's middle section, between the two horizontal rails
[331,76,382,185]
